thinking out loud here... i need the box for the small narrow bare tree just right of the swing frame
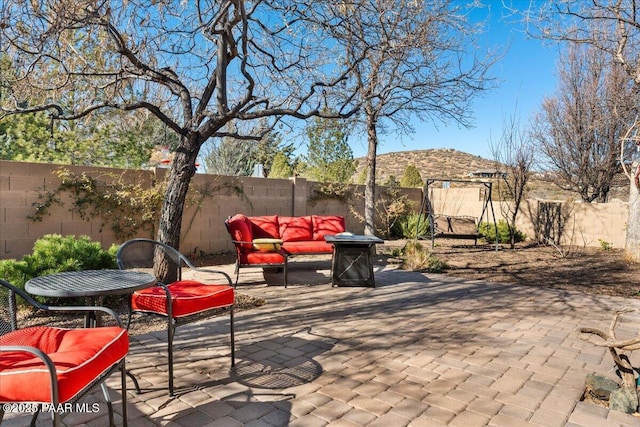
[489,115,535,249]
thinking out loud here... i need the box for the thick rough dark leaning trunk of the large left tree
[158,134,200,249]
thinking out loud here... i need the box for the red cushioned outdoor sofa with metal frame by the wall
[225,214,345,287]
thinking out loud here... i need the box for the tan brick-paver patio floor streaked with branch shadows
[3,261,640,427]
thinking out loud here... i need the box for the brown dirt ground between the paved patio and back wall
[196,239,640,298]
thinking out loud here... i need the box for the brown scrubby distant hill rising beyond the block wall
[354,148,629,201]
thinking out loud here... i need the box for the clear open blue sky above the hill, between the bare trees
[350,0,558,159]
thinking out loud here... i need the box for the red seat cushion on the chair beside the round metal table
[131,280,234,317]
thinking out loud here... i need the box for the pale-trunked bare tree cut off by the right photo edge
[524,0,640,261]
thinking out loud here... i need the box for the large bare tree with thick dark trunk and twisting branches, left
[0,0,359,251]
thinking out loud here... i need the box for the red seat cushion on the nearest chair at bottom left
[0,326,129,403]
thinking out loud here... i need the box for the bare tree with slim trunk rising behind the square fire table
[314,0,497,234]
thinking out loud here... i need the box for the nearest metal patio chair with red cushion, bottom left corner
[0,280,129,426]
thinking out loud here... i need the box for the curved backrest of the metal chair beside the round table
[116,239,186,284]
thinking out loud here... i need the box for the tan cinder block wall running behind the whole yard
[0,161,628,259]
